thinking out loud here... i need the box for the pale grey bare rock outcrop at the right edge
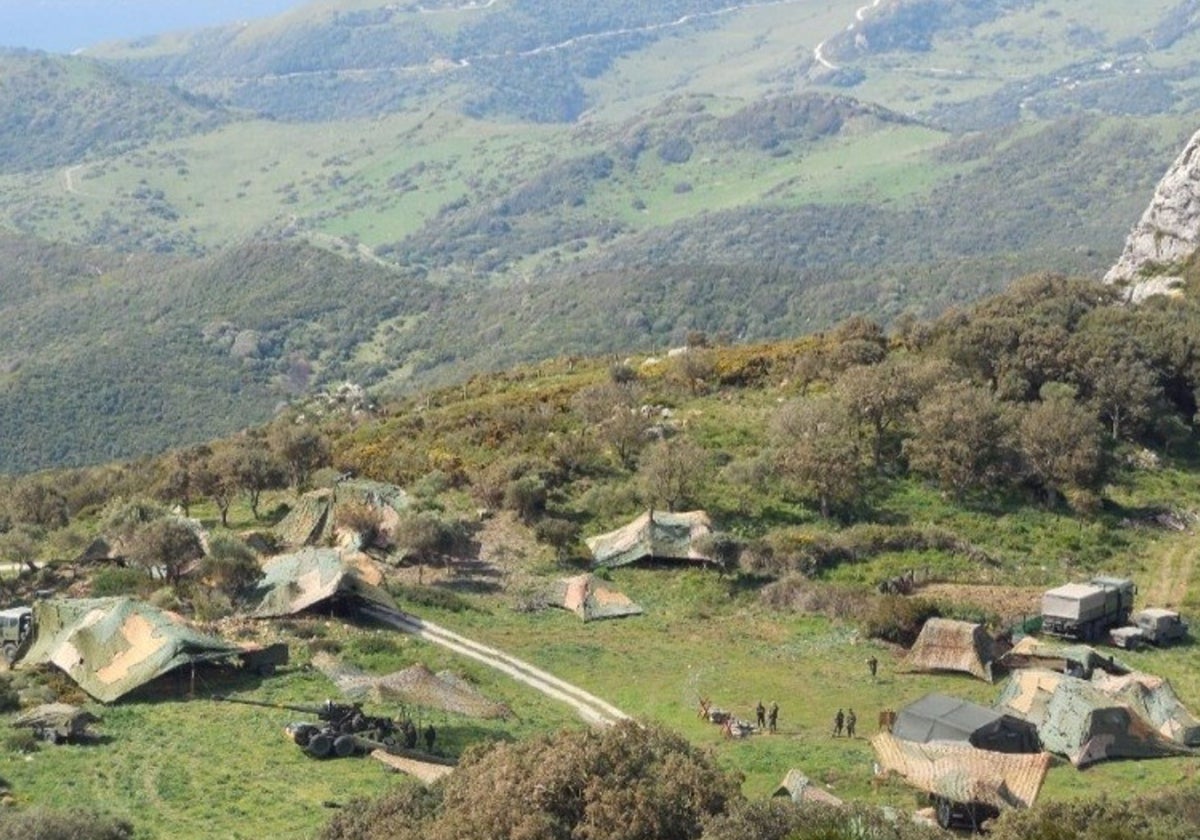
[1104,132,1200,301]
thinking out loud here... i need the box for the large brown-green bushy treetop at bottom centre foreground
[322,721,740,840]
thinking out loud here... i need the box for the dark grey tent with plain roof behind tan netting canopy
[892,692,1040,752]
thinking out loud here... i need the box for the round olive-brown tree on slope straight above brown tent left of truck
[904,382,1014,499]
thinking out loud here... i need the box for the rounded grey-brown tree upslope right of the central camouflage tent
[772,395,863,518]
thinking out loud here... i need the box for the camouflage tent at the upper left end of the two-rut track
[252,548,396,618]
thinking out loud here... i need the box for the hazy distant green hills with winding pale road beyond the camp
[0,0,1198,470]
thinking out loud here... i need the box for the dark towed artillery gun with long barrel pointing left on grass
[212,695,445,763]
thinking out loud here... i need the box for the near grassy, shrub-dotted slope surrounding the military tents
[7,278,1200,838]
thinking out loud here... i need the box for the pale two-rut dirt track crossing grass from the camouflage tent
[362,606,629,726]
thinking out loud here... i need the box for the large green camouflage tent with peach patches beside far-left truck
[25,598,242,703]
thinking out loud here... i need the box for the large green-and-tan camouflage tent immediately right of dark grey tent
[997,668,1187,767]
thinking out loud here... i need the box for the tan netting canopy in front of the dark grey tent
[871,732,1051,811]
